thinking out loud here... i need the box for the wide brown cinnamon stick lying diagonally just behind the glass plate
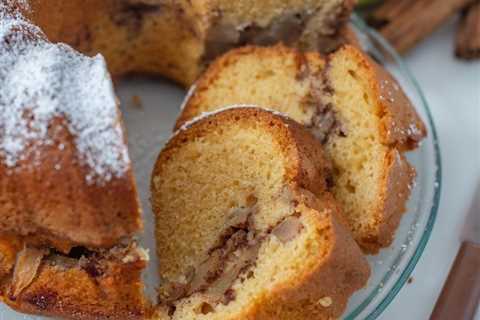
[369,0,472,53]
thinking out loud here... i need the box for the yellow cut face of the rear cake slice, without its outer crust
[177,46,398,249]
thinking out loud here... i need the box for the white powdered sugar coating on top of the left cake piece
[0,0,130,182]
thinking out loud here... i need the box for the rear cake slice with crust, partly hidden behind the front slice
[176,46,426,253]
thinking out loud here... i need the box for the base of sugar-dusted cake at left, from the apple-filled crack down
[0,243,151,320]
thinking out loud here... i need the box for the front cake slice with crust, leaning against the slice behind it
[151,107,369,320]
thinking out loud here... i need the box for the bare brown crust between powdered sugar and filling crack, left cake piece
[0,119,142,252]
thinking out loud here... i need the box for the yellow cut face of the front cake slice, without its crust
[152,118,331,319]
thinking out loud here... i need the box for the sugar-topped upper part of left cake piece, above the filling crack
[0,1,142,252]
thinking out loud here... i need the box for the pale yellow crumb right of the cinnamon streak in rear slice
[323,54,390,241]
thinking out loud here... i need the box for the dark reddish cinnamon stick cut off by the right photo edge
[455,0,480,60]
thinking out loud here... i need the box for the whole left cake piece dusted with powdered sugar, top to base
[0,0,149,319]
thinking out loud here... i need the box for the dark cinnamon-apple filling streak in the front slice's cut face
[161,208,304,307]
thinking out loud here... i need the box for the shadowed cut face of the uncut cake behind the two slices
[201,0,350,65]
